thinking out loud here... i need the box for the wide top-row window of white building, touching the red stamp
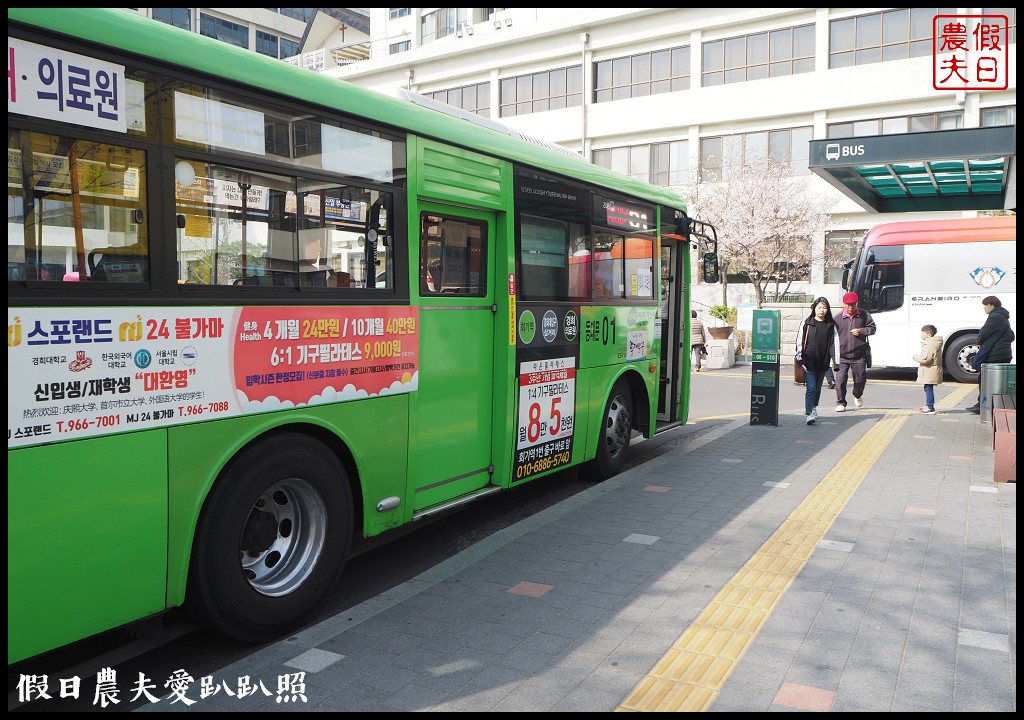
[828,7,956,69]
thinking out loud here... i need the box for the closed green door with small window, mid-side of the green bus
[410,204,495,515]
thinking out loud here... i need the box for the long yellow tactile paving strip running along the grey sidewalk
[617,405,929,713]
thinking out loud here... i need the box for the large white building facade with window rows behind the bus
[325,8,1017,304]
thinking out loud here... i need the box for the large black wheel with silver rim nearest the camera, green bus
[185,433,353,642]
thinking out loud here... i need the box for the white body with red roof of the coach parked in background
[848,217,1017,373]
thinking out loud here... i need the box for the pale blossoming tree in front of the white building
[685,162,835,307]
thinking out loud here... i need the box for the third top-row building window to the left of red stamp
[594,47,690,102]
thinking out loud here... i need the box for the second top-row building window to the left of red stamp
[700,25,814,87]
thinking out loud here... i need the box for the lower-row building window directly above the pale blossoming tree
[700,127,813,182]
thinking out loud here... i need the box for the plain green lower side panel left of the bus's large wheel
[7,430,168,664]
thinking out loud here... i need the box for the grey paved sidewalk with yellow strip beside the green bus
[140,387,1017,712]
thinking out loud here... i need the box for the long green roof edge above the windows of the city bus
[7,7,686,210]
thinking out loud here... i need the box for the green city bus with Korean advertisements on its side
[7,8,718,664]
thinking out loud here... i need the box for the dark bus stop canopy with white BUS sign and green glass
[808,125,1017,213]
